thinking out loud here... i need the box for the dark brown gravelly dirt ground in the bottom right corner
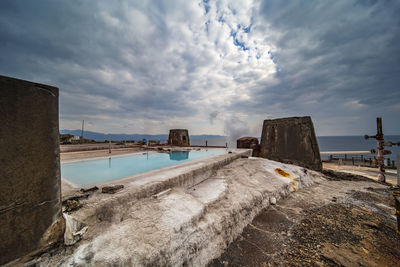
[209,170,400,266]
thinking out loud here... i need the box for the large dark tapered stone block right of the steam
[261,116,322,171]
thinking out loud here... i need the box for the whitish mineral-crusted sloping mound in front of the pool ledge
[42,158,324,266]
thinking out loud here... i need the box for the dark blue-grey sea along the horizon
[190,135,400,160]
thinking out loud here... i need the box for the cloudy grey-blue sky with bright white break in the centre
[0,0,400,136]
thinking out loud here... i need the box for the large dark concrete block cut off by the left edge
[0,76,65,265]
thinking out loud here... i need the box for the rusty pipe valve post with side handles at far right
[364,117,400,183]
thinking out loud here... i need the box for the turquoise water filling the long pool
[61,149,227,186]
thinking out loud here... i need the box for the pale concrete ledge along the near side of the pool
[69,149,251,223]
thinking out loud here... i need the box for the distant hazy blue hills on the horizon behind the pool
[60,129,225,141]
